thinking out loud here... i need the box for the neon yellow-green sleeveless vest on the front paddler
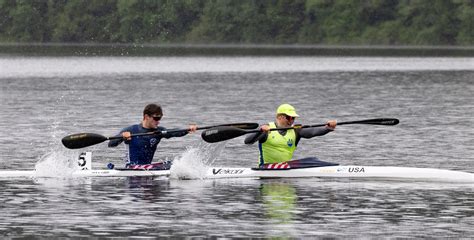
[258,122,296,165]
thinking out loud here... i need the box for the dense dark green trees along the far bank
[0,0,474,45]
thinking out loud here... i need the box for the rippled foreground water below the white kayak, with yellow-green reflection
[0,177,474,238]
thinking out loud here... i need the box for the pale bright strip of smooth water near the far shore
[0,56,474,79]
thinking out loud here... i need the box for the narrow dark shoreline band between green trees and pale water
[0,43,474,57]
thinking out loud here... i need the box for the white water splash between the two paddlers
[170,142,225,179]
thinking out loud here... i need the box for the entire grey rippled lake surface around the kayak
[0,56,474,238]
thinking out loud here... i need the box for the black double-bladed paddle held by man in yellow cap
[201,118,400,143]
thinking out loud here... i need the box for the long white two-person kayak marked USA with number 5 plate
[0,152,474,182]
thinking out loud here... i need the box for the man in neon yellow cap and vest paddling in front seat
[245,103,337,167]
